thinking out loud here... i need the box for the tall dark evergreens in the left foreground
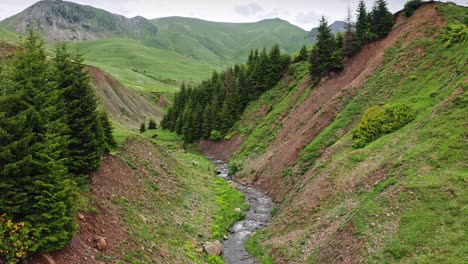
[0,31,115,262]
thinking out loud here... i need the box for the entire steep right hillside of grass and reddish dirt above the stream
[219,4,468,263]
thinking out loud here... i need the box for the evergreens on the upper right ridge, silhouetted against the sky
[310,0,393,81]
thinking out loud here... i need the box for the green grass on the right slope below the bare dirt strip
[238,4,468,263]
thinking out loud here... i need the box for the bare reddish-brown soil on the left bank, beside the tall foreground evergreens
[28,139,180,264]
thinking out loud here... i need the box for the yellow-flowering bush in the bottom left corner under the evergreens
[0,214,33,264]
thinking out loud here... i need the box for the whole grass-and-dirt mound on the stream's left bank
[36,130,246,264]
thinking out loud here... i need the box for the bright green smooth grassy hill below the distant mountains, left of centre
[70,39,213,92]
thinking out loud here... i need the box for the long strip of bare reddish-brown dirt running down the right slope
[236,4,444,200]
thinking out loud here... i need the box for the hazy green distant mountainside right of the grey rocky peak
[152,17,310,66]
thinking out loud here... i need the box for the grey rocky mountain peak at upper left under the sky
[0,0,157,42]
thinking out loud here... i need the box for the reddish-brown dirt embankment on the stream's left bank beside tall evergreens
[28,139,186,264]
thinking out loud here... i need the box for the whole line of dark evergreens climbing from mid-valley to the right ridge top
[161,0,393,143]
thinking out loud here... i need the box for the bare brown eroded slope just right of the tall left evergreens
[87,66,164,128]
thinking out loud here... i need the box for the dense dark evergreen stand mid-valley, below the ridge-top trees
[161,45,291,143]
